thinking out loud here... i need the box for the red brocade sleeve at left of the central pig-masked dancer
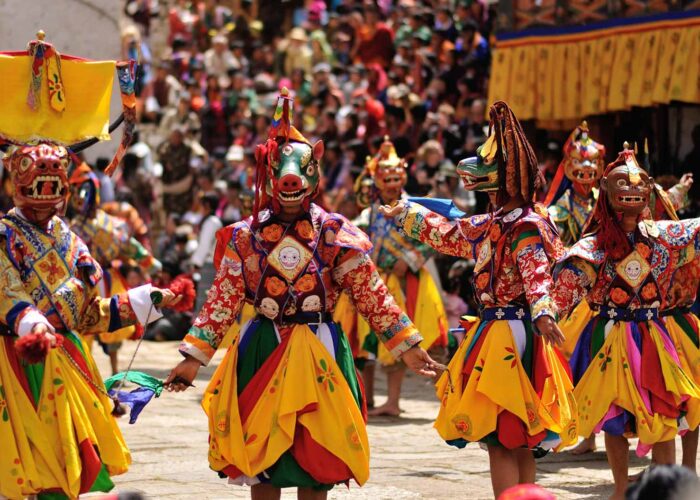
[180,244,245,365]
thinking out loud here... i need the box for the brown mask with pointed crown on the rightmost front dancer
[600,144,654,215]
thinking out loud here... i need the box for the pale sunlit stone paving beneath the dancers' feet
[95,342,696,500]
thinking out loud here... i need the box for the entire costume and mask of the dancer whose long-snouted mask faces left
[398,102,577,449]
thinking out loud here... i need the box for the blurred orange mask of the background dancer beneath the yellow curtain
[562,121,605,195]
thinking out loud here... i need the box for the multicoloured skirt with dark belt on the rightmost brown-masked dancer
[570,308,699,456]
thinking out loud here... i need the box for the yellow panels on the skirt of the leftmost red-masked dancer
[0,342,131,498]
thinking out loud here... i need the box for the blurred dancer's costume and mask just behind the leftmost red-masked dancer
[68,163,161,344]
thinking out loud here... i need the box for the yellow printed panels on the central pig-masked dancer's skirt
[202,325,369,485]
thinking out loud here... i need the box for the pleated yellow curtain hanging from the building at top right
[489,18,700,122]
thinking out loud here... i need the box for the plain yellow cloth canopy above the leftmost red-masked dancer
[0,54,115,144]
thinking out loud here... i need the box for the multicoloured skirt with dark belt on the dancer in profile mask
[435,307,578,450]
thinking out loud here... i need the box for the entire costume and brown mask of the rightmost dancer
[552,149,700,455]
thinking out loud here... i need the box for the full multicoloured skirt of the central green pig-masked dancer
[202,317,369,490]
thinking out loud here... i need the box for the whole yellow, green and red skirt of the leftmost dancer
[0,333,131,498]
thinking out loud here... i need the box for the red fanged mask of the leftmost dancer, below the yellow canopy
[4,144,69,225]
